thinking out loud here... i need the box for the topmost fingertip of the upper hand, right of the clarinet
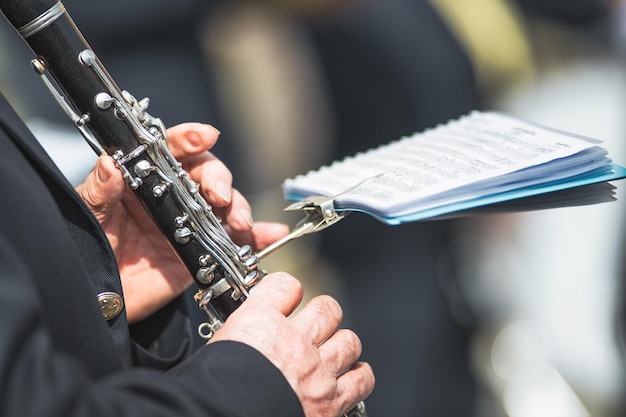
[167,123,220,159]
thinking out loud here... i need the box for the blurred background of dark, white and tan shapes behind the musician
[0,0,626,417]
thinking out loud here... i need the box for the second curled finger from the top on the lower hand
[293,295,343,345]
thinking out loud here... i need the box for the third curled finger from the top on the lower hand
[319,329,362,376]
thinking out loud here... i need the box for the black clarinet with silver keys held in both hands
[0,0,367,417]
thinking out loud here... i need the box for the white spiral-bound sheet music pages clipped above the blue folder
[283,112,606,218]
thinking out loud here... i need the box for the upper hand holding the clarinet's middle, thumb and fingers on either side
[77,123,287,323]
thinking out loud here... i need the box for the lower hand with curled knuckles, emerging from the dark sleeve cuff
[209,273,374,417]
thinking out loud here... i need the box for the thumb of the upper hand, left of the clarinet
[76,155,126,223]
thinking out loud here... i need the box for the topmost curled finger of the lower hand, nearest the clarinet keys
[242,272,303,316]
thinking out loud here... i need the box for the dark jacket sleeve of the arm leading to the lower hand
[0,235,303,417]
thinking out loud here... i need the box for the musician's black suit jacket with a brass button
[0,96,303,417]
